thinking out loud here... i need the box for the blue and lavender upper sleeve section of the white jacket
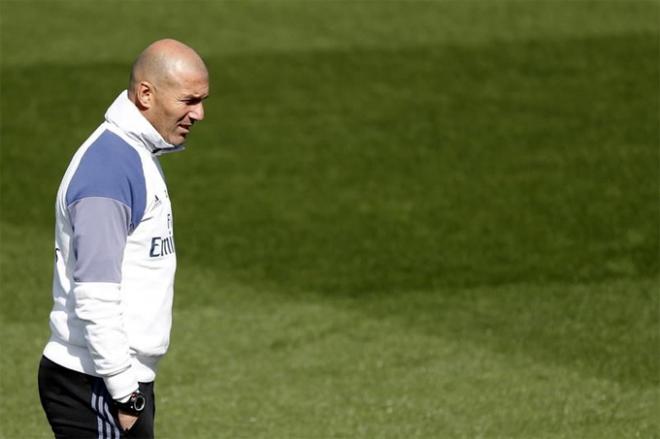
[66,131,146,283]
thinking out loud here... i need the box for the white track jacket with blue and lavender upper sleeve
[44,91,182,400]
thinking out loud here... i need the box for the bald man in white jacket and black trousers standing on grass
[39,39,209,438]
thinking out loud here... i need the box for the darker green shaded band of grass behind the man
[1,35,660,385]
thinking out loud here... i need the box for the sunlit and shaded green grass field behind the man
[0,0,660,439]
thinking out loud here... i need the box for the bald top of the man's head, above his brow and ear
[128,39,208,97]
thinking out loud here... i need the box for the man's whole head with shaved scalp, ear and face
[128,39,209,145]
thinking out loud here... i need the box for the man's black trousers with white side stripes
[39,357,156,439]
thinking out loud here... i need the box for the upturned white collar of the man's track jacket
[105,90,185,156]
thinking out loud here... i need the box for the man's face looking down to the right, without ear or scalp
[149,70,209,145]
